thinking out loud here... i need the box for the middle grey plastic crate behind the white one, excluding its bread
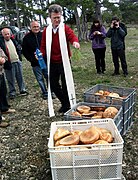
[64,102,123,135]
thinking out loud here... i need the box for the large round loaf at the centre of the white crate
[80,126,99,144]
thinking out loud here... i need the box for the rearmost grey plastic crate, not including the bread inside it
[84,84,136,135]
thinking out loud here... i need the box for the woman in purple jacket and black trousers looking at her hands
[89,19,106,74]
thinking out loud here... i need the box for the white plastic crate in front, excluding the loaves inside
[48,119,123,180]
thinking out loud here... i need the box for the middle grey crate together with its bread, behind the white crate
[64,102,123,133]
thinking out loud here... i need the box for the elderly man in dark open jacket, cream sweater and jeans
[0,28,28,99]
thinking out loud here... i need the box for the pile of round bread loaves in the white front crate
[53,126,114,147]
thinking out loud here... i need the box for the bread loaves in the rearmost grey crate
[95,90,125,99]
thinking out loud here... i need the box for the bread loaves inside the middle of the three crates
[71,105,118,119]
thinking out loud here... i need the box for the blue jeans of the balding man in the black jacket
[32,66,48,95]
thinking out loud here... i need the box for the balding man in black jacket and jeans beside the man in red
[22,21,48,99]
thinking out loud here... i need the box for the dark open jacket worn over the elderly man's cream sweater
[0,36,22,61]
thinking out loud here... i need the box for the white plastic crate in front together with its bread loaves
[48,119,123,180]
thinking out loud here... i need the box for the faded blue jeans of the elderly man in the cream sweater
[5,61,26,95]
